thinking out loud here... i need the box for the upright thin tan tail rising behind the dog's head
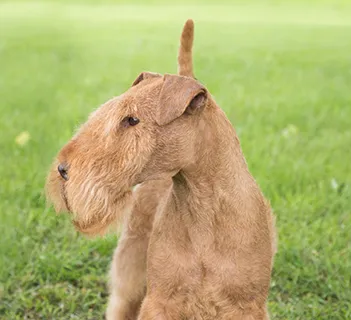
[178,19,194,78]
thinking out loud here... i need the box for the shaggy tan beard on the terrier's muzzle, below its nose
[46,168,132,235]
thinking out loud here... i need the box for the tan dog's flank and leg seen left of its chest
[106,181,171,320]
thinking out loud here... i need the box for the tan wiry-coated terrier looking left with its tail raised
[47,20,275,320]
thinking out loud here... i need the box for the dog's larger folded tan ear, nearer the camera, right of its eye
[156,74,207,126]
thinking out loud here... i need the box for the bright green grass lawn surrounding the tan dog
[0,0,351,320]
